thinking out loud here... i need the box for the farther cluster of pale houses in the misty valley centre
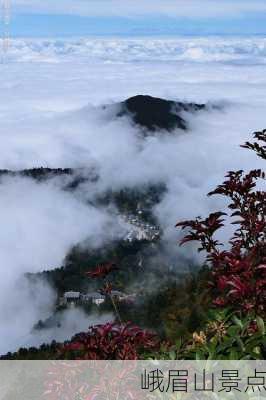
[125,215,160,242]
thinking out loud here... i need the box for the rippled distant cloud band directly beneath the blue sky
[6,37,266,64]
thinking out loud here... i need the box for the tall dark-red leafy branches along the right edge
[177,130,266,315]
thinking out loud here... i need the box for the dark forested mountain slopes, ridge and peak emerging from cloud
[0,96,211,357]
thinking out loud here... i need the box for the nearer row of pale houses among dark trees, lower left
[59,290,136,306]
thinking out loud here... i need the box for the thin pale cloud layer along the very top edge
[13,0,266,18]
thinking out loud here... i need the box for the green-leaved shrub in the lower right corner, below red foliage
[148,309,266,360]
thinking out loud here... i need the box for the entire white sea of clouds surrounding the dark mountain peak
[0,38,266,353]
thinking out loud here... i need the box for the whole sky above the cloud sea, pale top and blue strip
[8,0,266,37]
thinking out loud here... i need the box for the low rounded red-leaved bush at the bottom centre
[59,323,159,360]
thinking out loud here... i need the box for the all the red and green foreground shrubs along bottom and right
[3,130,266,360]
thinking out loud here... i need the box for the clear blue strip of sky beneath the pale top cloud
[10,4,266,37]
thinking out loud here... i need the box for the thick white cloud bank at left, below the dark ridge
[0,178,127,354]
